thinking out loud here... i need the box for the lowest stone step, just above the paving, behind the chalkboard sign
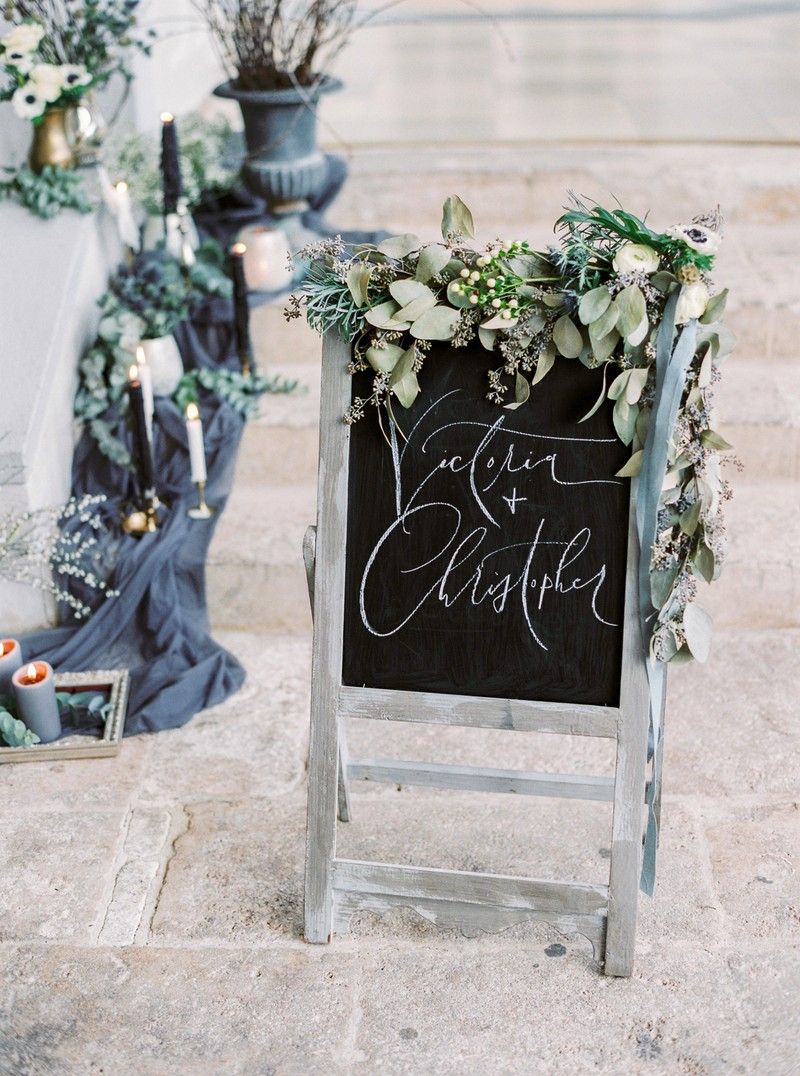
[208,478,800,633]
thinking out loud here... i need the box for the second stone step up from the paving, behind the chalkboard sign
[238,350,800,484]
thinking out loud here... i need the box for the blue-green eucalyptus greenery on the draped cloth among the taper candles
[74,240,297,467]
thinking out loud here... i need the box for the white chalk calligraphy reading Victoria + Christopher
[359,391,622,651]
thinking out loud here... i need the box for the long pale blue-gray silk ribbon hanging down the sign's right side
[634,291,697,895]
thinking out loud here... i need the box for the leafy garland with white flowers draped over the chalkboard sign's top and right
[286,196,733,662]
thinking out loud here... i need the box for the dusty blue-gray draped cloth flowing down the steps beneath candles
[22,299,244,735]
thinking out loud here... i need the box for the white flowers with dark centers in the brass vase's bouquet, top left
[0,22,94,123]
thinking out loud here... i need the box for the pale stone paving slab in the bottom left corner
[0,945,359,1076]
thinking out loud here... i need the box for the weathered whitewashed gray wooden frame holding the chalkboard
[304,334,648,976]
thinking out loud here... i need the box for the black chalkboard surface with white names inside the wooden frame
[342,344,630,706]
